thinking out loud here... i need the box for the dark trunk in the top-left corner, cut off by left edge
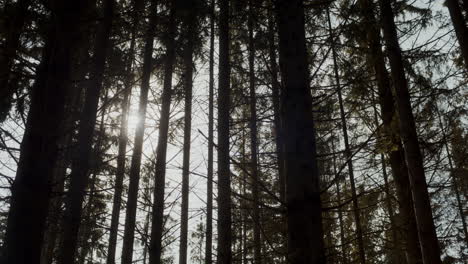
[0,0,32,122]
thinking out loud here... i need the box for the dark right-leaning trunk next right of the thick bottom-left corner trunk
[59,0,114,264]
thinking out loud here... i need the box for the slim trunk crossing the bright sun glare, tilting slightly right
[122,0,157,264]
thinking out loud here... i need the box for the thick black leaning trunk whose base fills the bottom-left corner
[0,1,90,264]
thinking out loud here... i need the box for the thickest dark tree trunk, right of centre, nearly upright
[276,0,325,264]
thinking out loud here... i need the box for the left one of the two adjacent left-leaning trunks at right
[359,0,422,264]
